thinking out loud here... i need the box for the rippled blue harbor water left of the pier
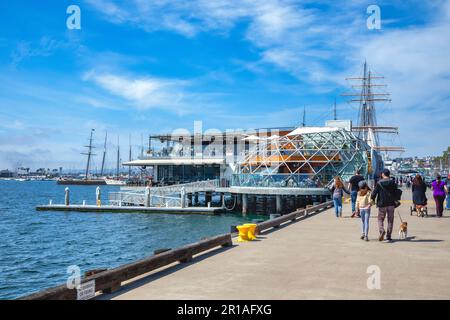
[0,180,262,299]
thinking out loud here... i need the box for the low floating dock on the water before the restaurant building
[36,204,225,215]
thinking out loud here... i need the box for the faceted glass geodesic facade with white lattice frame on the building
[232,127,372,188]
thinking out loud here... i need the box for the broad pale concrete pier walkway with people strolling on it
[99,190,450,300]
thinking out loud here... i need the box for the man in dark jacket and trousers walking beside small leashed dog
[371,169,397,241]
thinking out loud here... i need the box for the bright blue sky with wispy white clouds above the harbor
[0,0,450,169]
